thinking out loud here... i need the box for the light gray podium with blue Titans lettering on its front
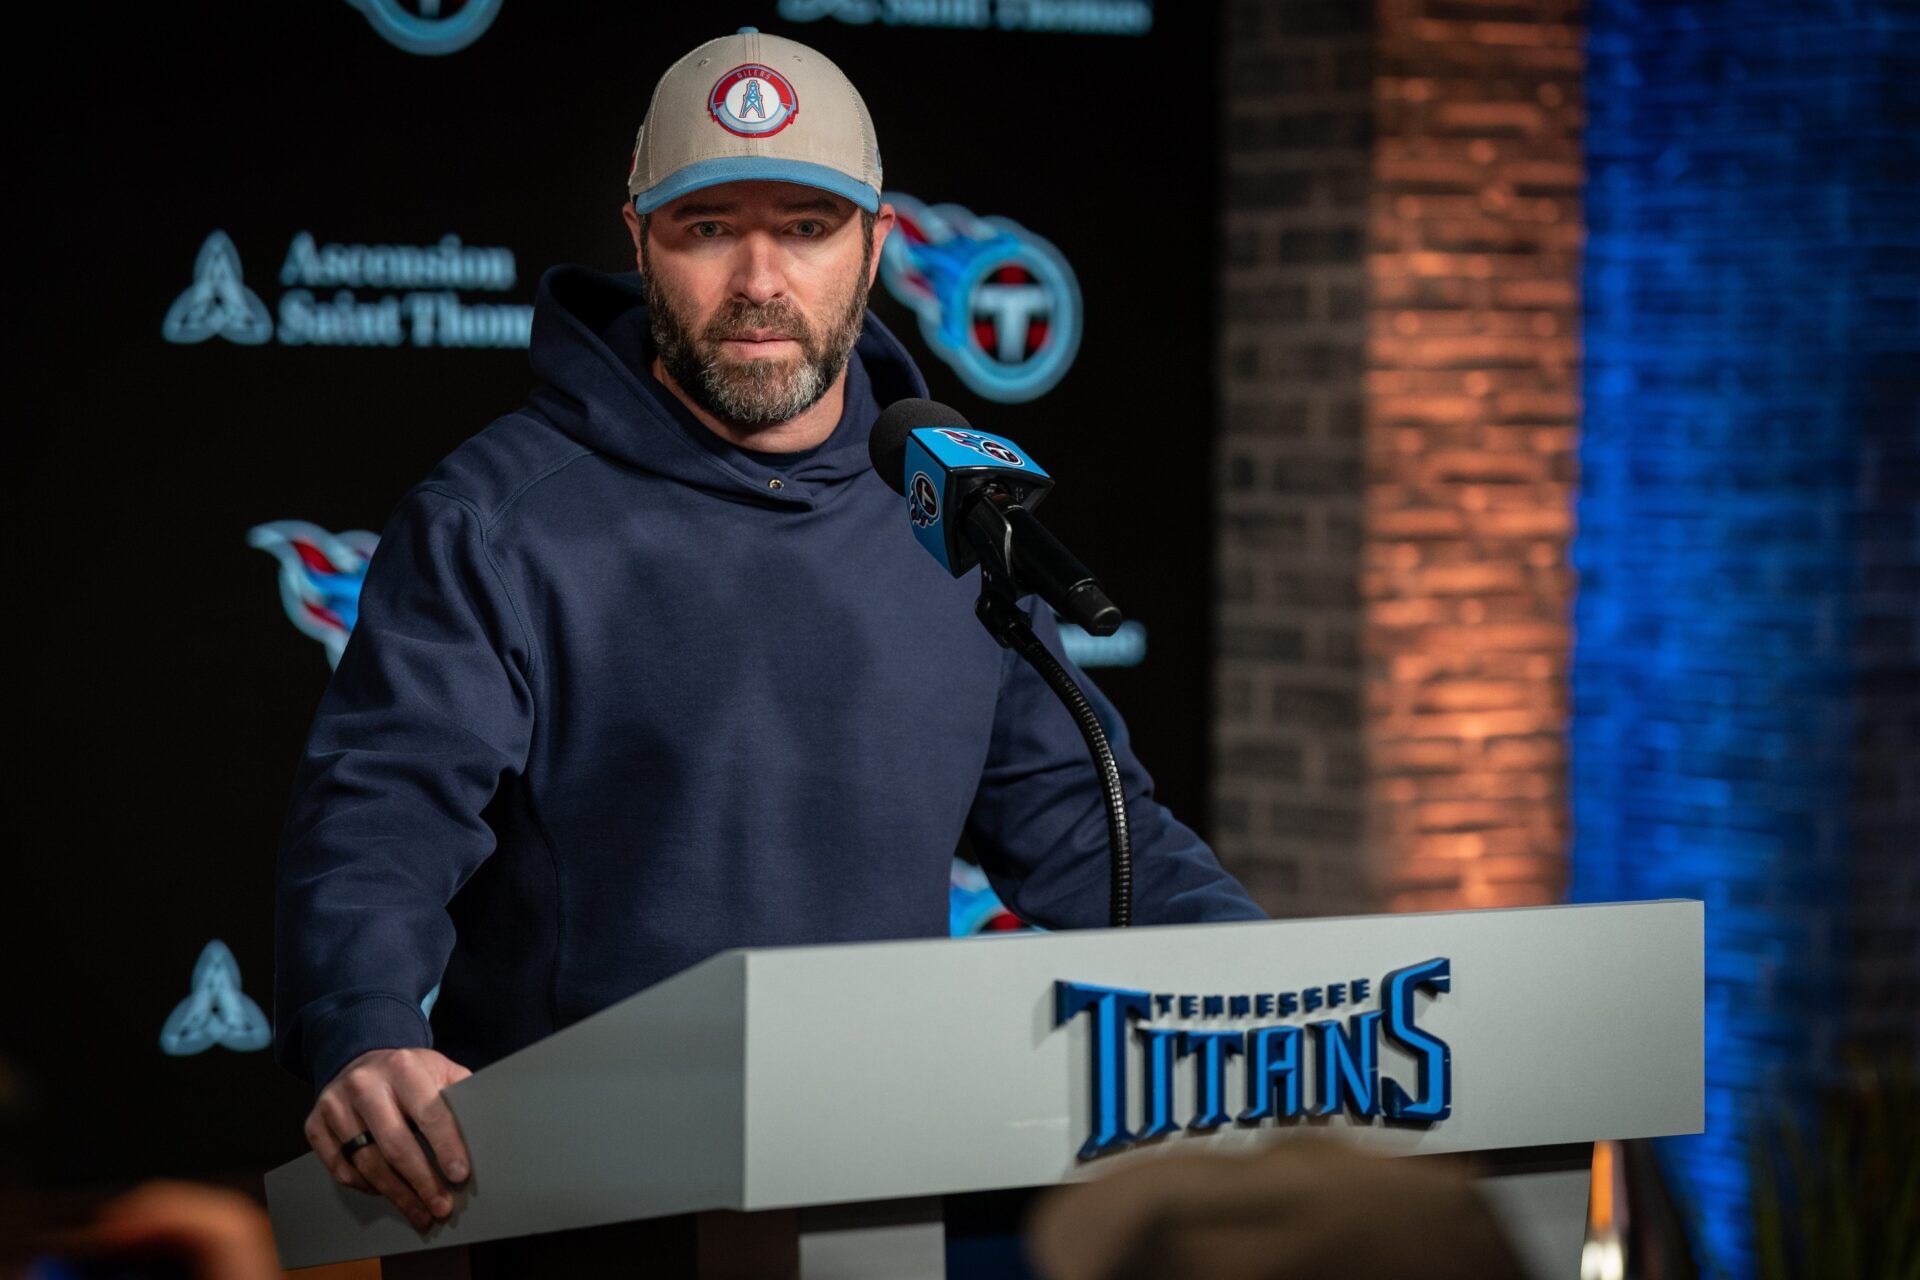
[267,900,1703,1280]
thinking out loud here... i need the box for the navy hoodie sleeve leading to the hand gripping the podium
[273,489,534,1088]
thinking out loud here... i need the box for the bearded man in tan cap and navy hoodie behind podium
[275,29,1261,1228]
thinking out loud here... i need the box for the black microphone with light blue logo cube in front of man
[866,399,1121,635]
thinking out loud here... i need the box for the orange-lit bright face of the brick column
[1361,0,1582,910]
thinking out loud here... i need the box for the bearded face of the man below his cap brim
[628,182,893,430]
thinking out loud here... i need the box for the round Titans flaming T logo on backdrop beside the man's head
[879,194,1081,403]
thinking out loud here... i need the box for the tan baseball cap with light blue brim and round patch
[626,27,879,213]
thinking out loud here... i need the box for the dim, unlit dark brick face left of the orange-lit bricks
[1213,0,1373,915]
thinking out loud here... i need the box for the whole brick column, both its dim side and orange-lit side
[1213,0,1582,915]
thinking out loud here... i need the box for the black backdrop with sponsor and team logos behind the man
[8,0,1213,1182]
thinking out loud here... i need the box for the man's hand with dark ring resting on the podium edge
[307,1050,472,1232]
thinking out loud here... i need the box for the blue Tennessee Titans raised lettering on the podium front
[1054,956,1453,1159]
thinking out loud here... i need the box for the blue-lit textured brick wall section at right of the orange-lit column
[1572,0,1920,1276]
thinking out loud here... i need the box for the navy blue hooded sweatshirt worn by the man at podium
[275,267,1261,1084]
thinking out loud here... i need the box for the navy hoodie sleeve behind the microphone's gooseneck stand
[968,601,1267,929]
